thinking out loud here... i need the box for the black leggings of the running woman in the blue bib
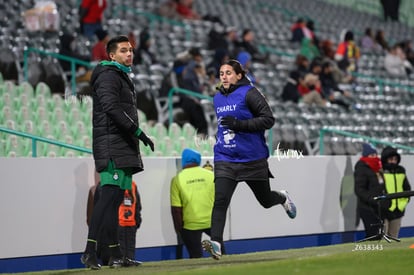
[211,178,286,248]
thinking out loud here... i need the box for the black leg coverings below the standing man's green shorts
[87,185,124,252]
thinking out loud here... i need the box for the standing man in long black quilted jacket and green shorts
[81,36,154,269]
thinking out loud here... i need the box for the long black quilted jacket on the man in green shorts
[91,64,143,173]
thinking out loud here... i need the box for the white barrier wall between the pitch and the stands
[0,156,414,258]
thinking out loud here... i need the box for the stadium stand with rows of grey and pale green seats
[0,0,414,157]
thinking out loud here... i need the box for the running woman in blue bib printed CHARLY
[202,60,296,260]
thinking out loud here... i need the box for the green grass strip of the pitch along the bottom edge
[8,238,414,275]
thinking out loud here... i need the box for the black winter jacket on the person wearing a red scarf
[354,160,389,212]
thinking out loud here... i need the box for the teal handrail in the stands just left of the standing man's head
[23,47,93,95]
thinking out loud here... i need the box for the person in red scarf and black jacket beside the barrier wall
[354,143,389,238]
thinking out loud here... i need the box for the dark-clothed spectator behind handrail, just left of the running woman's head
[179,48,208,136]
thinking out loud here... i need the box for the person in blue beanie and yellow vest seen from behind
[170,148,214,258]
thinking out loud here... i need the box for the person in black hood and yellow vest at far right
[381,146,411,238]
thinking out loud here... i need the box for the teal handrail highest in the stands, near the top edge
[112,5,191,41]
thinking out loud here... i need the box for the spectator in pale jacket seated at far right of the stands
[384,44,413,77]
